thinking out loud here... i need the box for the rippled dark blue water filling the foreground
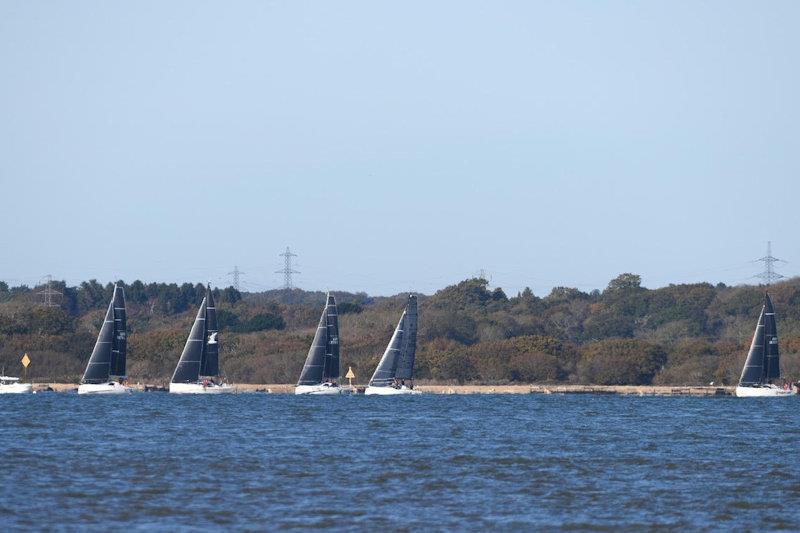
[0,393,800,530]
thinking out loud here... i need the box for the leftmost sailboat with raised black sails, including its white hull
[78,284,131,394]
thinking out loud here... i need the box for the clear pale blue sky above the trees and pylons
[0,0,800,295]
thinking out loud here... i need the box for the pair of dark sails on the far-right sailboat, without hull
[739,294,781,386]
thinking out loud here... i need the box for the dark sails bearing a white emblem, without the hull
[171,287,219,383]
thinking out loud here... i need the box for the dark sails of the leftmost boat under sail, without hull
[81,285,128,383]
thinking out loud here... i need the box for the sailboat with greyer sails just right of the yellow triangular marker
[364,294,420,396]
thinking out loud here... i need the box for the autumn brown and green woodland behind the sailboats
[0,273,800,385]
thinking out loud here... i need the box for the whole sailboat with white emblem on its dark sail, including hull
[169,286,233,394]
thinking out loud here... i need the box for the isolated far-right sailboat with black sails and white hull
[736,293,794,398]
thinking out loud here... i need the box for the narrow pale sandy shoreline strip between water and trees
[28,383,736,396]
